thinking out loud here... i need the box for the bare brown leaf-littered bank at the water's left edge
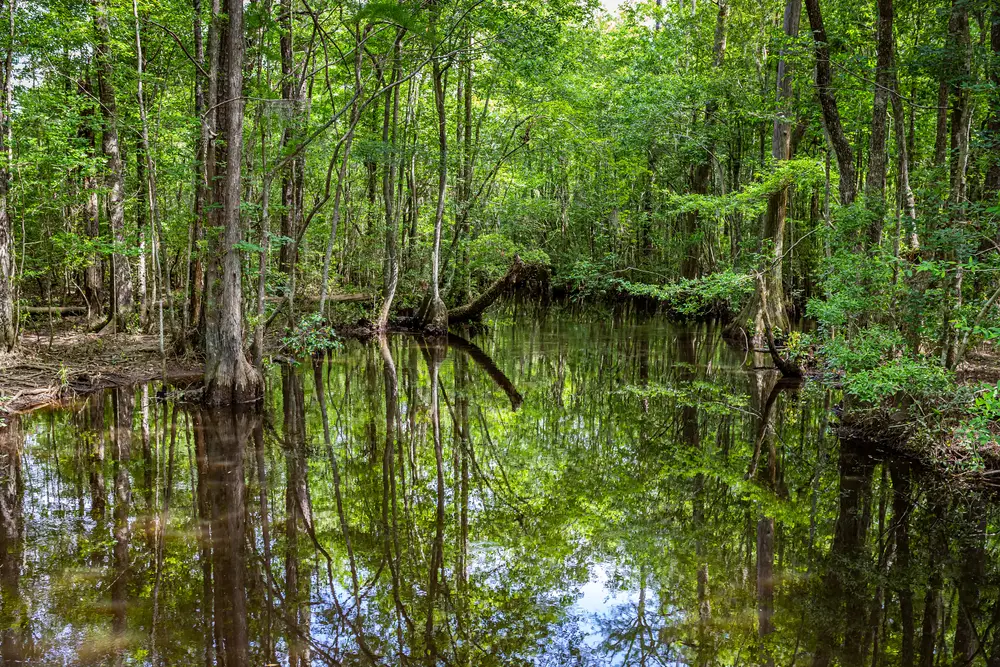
[0,320,203,416]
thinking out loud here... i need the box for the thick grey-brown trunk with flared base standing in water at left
[204,0,263,405]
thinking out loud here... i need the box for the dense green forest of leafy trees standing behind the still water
[0,0,1000,402]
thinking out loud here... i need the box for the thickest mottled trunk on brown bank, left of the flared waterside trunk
[92,0,134,332]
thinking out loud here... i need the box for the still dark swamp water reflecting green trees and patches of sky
[0,317,1000,667]
